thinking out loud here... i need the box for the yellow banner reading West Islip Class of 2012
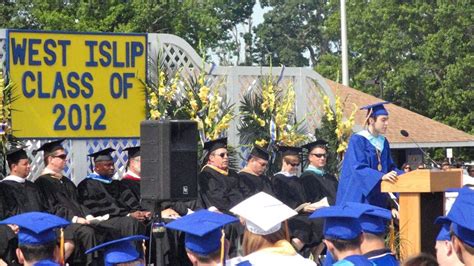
[7,30,147,138]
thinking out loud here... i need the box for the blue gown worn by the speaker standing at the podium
[336,134,403,208]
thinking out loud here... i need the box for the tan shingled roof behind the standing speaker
[327,80,474,149]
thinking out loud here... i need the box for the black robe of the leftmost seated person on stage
[0,180,48,220]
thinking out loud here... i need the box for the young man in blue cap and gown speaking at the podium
[336,102,403,208]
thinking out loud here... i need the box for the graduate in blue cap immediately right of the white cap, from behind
[309,204,375,265]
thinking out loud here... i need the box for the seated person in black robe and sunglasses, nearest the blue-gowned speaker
[300,140,339,205]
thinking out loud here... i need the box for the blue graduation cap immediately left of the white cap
[165,210,238,255]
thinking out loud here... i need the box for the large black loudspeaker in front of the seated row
[140,120,198,203]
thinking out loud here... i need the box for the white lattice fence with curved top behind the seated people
[0,29,334,184]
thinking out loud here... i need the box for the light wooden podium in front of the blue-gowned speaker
[381,169,462,259]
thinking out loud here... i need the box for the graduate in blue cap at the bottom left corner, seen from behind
[0,212,69,266]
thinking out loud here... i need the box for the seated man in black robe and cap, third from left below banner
[77,148,146,239]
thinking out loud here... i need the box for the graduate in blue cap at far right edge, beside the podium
[437,187,474,265]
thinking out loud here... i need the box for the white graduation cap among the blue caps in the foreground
[230,192,298,235]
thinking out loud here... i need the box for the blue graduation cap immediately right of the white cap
[309,204,367,240]
